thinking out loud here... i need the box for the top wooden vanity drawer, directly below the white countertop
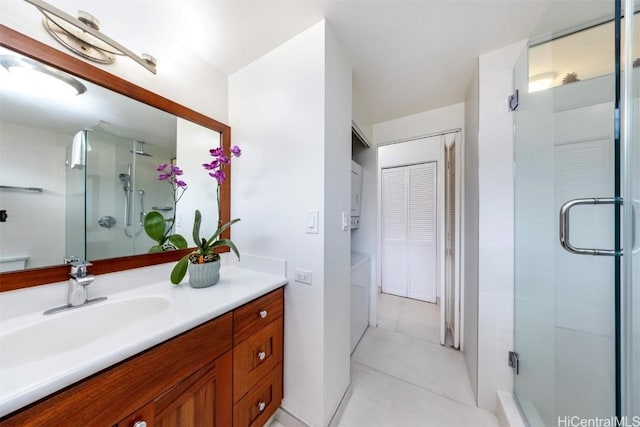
[233,288,284,344]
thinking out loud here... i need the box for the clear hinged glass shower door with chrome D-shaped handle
[514,2,620,426]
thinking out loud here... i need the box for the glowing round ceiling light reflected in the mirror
[0,55,87,96]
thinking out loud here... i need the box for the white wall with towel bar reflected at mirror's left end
[0,121,66,268]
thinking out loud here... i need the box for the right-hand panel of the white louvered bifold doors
[407,162,438,303]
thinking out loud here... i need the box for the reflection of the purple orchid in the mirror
[144,163,187,253]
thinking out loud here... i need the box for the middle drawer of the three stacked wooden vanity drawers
[233,317,283,402]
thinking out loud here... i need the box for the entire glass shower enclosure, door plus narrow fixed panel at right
[511,0,640,426]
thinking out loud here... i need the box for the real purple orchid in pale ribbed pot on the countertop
[171,146,241,288]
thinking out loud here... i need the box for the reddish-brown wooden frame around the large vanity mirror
[0,24,231,292]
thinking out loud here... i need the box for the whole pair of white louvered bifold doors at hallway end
[382,162,437,302]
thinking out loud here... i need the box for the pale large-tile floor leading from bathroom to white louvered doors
[338,294,499,427]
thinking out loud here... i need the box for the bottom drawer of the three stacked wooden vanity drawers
[233,363,282,427]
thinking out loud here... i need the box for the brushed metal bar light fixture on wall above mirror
[25,0,157,74]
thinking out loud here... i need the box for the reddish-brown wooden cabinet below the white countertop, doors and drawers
[0,288,284,427]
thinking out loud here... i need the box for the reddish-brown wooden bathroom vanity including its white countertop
[0,267,286,427]
